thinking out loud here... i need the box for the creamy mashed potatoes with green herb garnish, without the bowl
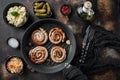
[6,6,27,27]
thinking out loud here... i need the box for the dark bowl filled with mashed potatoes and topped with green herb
[3,3,29,27]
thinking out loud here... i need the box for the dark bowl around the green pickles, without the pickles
[33,1,53,19]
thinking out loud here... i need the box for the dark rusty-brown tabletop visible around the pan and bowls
[0,0,120,80]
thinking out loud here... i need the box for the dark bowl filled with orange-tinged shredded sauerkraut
[5,56,25,74]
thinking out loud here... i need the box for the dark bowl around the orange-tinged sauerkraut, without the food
[5,56,25,75]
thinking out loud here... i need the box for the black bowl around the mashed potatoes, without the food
[3,3,29,27]
